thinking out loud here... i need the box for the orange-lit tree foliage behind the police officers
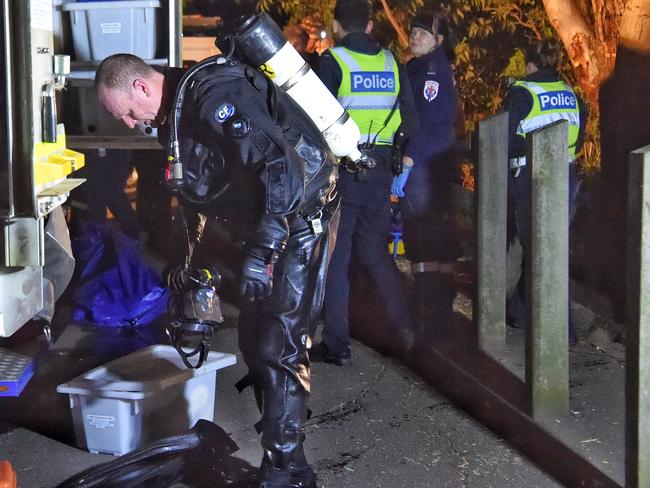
[259,0,600,167]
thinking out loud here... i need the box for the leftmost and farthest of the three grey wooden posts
[475,113,508,352]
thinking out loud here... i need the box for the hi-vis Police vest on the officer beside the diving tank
[330,47,402,144]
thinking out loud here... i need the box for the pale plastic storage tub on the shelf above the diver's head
[62,0,160,61]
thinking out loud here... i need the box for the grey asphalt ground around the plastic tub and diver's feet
[0,302,561,488]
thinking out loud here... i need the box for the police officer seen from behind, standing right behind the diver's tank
[311,0,417,366]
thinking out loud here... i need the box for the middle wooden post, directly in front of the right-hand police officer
[526,120,569,420]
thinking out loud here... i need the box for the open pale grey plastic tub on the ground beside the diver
[56,345,236,456]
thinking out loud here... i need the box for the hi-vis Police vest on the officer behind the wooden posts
[515,81,580,162]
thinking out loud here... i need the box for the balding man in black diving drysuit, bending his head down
[96,54,338,488]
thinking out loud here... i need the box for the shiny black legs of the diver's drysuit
[239,201,339,470]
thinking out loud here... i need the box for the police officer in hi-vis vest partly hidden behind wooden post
[504,40,587,343]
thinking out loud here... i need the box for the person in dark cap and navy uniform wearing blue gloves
[392,12,460,332]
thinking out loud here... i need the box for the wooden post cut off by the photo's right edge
[625,146,650,488]
